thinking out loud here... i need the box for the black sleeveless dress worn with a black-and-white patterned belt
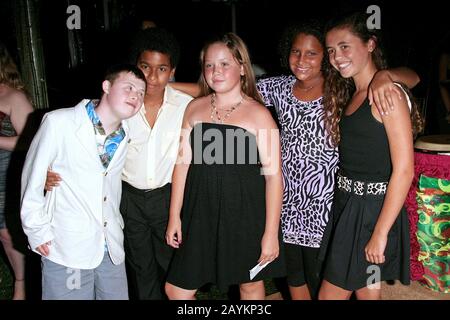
[324,99,410,291]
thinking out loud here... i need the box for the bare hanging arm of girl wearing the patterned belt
[365,93,414,263]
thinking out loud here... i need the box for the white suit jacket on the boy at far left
[20,100,129,269]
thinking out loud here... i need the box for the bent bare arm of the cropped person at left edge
[0,90,33,151]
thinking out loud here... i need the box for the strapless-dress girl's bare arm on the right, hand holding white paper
[257,109,283,264]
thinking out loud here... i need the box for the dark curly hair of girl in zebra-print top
[278,19,330,75]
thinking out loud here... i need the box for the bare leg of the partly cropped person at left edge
[0,228,25,300]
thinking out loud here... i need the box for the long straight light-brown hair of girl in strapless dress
[199,32,264,104]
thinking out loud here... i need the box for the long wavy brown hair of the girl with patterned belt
[323,13,423,146]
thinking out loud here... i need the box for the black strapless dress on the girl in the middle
[167,123,285,290]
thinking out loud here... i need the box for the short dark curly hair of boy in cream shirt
[130,27,180,68]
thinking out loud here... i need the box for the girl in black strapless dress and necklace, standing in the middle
[166,33,285,299]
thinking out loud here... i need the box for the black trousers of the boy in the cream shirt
[120,182,173,300]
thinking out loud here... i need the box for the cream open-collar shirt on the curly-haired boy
[122,86,192,189]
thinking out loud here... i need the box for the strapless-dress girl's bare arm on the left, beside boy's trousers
[166,106,192,248]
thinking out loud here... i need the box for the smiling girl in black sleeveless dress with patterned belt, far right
[319,13,420,299]
